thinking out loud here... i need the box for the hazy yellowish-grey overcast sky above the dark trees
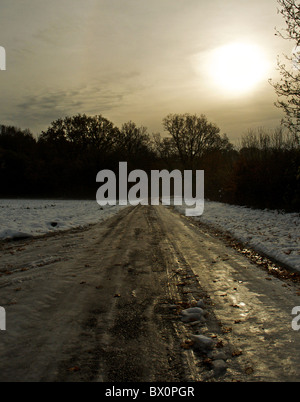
[0,0,293,139]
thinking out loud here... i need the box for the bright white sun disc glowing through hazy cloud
[208,43,268,95]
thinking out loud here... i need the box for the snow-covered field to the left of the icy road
[0,199,124,239]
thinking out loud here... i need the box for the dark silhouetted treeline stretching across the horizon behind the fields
[0,114,300,211]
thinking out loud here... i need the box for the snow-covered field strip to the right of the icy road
[176,201,300,271]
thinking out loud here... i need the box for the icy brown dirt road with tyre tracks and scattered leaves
[0,206,300,382]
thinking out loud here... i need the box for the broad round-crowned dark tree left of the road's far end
[38,114,120,197]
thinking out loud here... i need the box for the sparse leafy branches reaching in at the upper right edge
[270,0,300,143]
